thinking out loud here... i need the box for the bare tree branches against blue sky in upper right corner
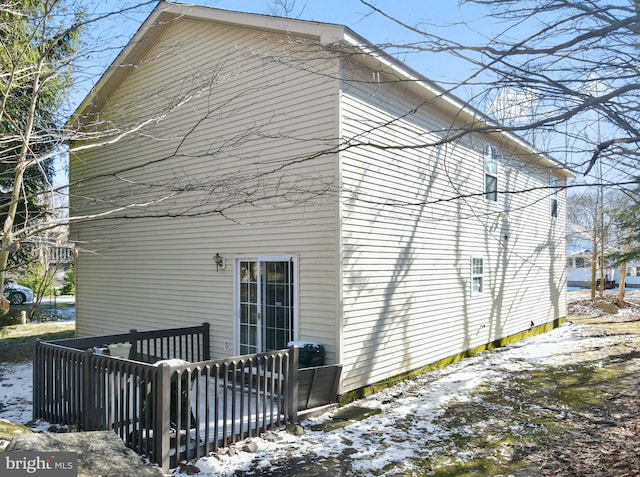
[361,0,640,183]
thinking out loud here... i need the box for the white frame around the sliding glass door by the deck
[232,254,300,356]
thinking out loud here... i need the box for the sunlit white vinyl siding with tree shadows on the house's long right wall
[341,62,565,390]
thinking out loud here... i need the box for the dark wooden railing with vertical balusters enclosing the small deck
[33,324,304,472]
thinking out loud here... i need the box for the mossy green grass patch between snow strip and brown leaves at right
[407,332,639,477]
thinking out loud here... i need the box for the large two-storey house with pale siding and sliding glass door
[70,2,570,393]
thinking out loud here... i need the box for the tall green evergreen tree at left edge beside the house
[0,0,82,302]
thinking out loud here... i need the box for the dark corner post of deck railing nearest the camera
[153,363,171,474]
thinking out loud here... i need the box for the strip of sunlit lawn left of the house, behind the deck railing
[0,321,76,363]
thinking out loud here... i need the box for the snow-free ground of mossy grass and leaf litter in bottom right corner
[234,292,640,477]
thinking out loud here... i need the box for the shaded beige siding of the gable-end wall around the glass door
[71,19,338,360]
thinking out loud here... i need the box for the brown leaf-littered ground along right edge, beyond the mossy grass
[520,293,640,477]
